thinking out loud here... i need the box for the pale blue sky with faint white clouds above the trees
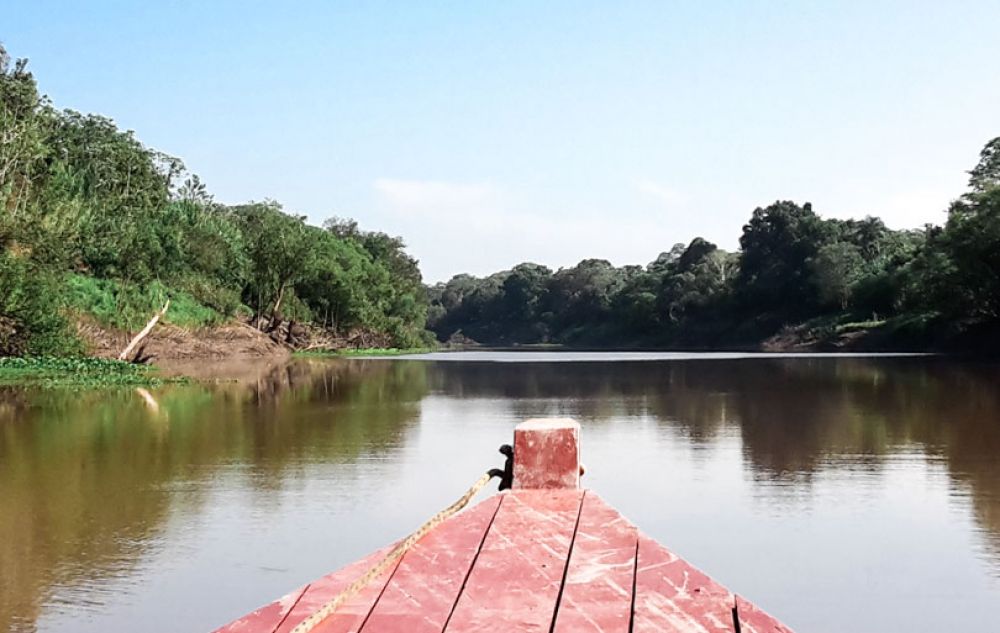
[7,0,1000,281]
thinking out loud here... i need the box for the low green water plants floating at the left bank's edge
[0,357,187,387]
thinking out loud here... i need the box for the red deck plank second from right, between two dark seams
[633,534,735,633]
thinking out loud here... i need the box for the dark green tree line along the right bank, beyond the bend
[428,138,1000,347]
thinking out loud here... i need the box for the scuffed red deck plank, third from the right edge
[555,491,639,633]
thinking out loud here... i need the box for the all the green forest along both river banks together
[0,47,1000,356]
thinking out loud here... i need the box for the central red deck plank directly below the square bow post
[446,490,583,633]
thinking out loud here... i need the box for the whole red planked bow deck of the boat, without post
[217,490,791,633]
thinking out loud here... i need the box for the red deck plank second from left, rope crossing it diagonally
[274,547,395,633]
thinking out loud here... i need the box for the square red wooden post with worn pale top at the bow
[513,418,580,489]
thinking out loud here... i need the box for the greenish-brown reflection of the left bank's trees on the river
[0,362,426,631]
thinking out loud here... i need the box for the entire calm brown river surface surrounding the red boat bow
[0,352,1000,633]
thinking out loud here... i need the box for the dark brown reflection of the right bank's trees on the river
[429,358,1000,556]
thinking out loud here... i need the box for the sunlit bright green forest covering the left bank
[0,47,429,356]
